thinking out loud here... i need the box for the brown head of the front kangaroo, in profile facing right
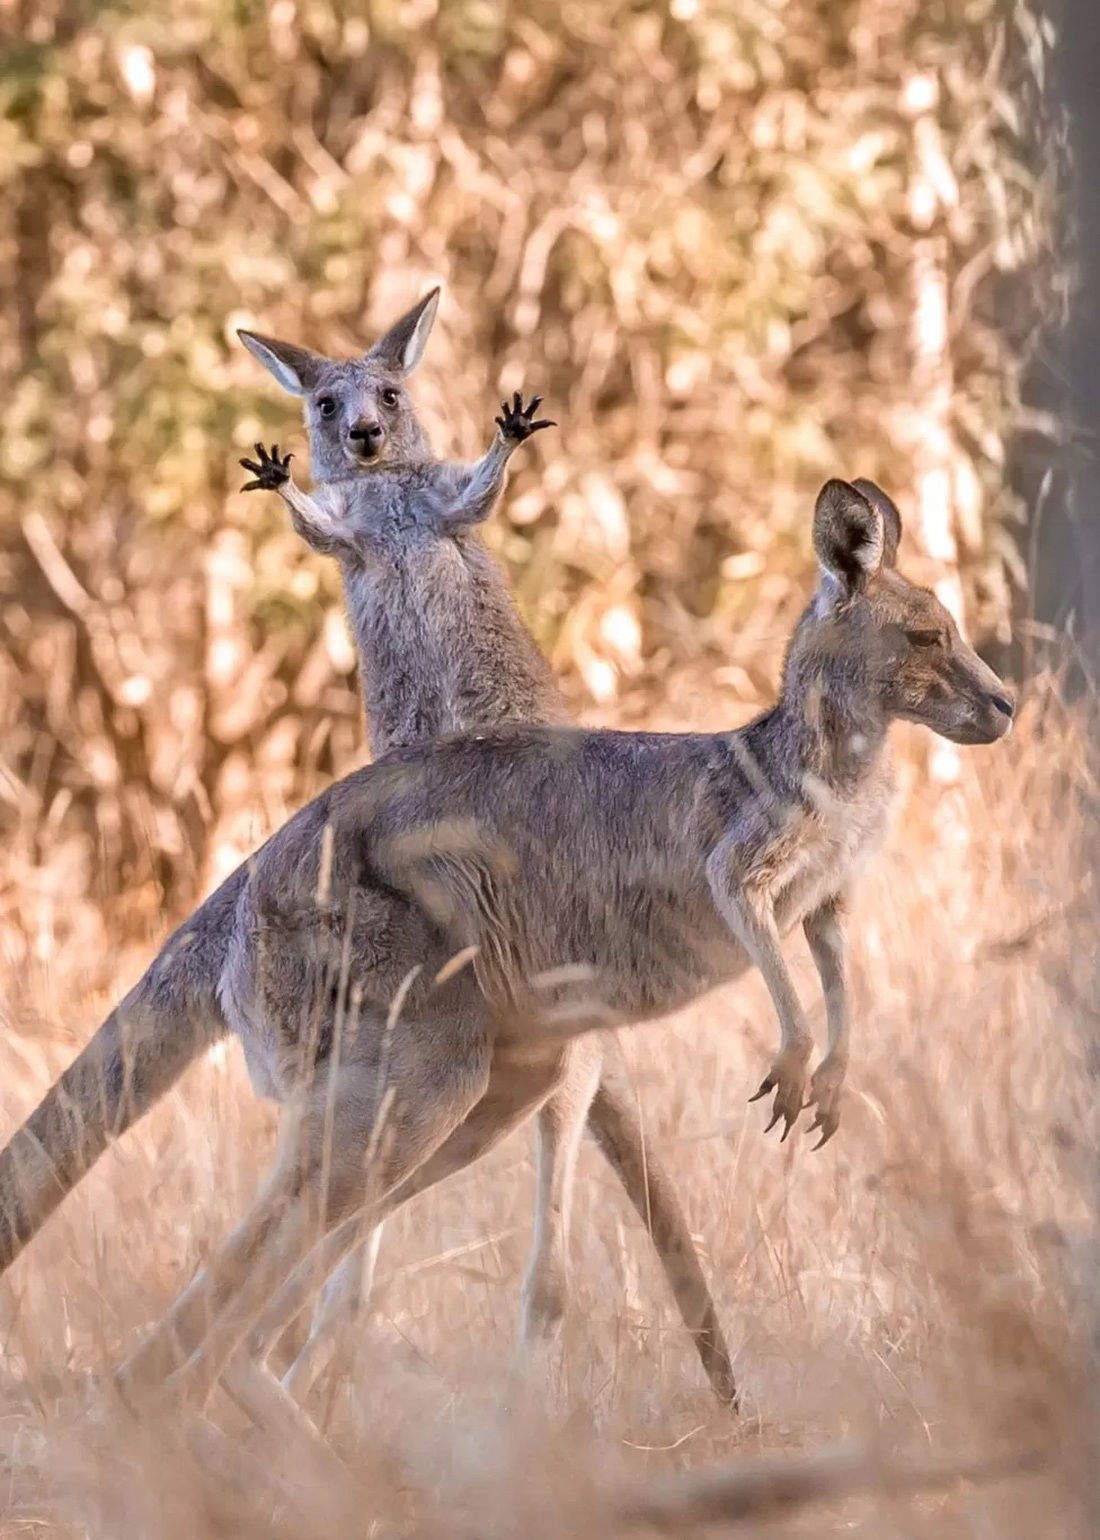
[786,480,1015,744]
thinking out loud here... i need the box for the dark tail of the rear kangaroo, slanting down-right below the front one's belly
[589,1053,738,1409]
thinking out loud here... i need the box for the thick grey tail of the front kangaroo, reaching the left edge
[0,870,243,1274]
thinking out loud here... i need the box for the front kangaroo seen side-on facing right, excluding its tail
[55,480,1014,1394]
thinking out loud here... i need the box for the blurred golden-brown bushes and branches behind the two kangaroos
[0,0,1060,961]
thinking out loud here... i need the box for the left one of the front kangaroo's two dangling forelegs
[707,841,813,1140]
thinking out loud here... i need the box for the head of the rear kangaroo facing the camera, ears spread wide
[237,288,439,482]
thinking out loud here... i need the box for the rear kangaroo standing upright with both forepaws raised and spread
[240,290,735,1401]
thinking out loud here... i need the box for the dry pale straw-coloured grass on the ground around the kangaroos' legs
[0,684,1095,1540]
